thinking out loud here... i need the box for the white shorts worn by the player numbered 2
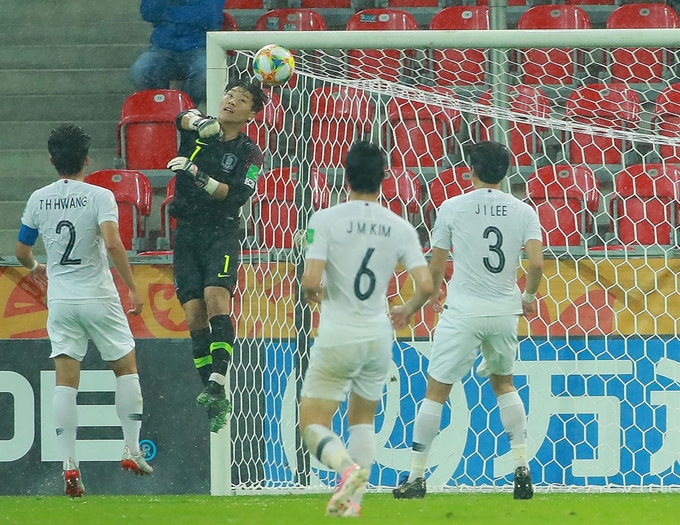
[47,301,135,361]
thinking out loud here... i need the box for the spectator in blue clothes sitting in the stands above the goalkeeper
[130,0,224,106]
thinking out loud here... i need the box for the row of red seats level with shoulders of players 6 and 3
[86,164,680,253]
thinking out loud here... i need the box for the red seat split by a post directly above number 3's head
[476,85,550,166]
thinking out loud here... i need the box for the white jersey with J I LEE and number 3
[432,188,541,317]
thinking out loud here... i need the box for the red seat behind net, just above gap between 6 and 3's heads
[385,86,461,167]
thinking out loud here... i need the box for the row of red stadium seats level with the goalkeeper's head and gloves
[118,83,680,174]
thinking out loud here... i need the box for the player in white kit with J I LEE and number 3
[393,142,543,499]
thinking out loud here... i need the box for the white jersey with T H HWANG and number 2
[21,179,119,303]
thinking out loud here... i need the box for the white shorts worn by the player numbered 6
[302,337,393,401]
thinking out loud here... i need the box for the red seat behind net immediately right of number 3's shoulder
[527,164,600,247]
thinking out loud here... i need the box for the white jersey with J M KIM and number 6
[307,200,427,345]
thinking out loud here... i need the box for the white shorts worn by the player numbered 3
[428,311,519,385]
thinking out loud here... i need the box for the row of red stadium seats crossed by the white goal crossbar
[235,3,680,85]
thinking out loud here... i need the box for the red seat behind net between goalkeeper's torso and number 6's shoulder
[252,167,330,249]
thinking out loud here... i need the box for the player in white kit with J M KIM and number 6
[300,142,433,517]
